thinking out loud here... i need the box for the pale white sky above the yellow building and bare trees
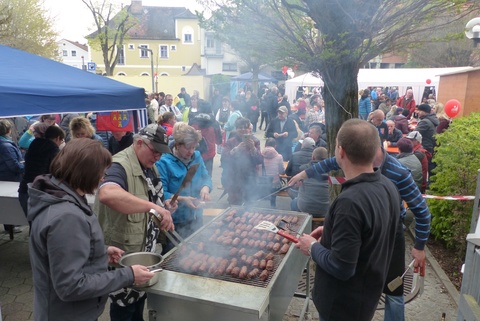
[43,0,201,44]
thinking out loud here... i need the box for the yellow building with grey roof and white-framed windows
[90,0,201,91]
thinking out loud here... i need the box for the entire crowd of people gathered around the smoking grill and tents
[0,86,442,321]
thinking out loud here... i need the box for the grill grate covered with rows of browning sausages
[162,208,306,288]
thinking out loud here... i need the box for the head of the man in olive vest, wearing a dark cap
[133,124,171,168]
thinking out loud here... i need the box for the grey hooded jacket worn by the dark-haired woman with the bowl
[28,175,134,321]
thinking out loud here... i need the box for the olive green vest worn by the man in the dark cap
[94,145,158,253]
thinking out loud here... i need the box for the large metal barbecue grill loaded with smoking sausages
[144,207,311,321]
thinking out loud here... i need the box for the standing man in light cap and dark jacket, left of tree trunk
[265,106,298,162]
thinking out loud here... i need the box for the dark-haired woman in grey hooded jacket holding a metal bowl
[28,138,154,320]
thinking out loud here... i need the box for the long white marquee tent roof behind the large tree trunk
[285,67,472,103]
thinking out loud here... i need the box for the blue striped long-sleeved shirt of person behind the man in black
[305,153,431,251]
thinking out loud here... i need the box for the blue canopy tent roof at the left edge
[0,45,145,124]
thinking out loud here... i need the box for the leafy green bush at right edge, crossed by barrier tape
[428,113,480,256]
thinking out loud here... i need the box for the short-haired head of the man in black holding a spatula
[335,118,380,166]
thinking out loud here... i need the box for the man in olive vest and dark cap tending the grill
[95,124,176,321]
